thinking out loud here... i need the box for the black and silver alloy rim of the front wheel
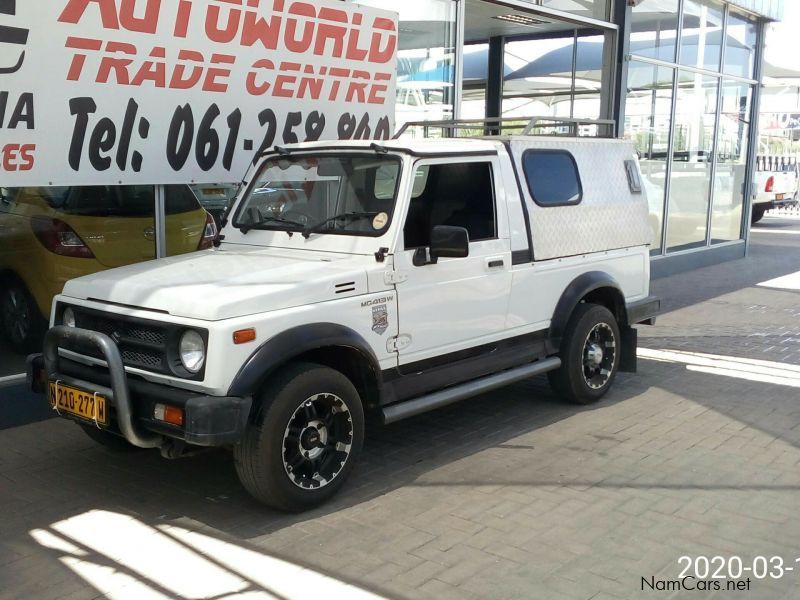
[282,393,353,490]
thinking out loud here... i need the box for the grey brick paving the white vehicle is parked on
[0,218,800,600]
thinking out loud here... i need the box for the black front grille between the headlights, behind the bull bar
[72,306,172,374]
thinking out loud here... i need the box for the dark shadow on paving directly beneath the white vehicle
[0,377,628,538]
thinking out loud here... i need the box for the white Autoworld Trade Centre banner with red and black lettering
[0,0,398,187]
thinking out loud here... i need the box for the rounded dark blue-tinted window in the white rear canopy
[522,150,583,206]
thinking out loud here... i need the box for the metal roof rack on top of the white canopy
[394,116,617,139]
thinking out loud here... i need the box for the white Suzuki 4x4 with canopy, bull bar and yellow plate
[29,119,659,511]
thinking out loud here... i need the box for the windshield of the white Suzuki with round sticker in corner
[233,155,400,237]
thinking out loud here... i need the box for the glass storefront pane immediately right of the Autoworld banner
[350,0,457,133]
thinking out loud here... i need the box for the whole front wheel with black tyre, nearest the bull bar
[233,363,364,512]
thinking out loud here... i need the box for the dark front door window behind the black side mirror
[403,162,497,250]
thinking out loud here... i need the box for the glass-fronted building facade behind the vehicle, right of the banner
[372,0,783,276]
